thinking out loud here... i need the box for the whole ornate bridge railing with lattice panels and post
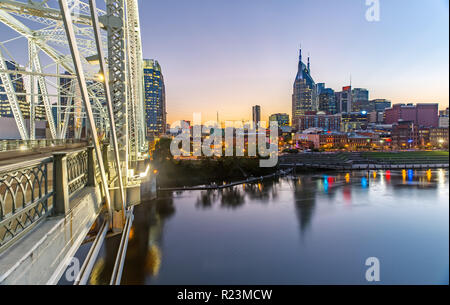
[0,147,99,253]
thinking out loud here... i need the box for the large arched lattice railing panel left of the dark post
[0,158,53,252]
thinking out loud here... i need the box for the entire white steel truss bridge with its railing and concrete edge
[0,0,154,284]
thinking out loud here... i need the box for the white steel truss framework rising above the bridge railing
[0,0,147,177]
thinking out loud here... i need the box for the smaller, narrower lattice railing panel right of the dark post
[67,150,88,195]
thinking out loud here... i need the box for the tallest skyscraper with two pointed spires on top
[292,49,318,128]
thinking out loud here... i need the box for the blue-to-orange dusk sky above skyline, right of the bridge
[139,0,449,123]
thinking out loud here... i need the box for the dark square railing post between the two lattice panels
[53,152,69,215]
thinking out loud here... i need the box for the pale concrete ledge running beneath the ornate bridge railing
[0,187,101,285]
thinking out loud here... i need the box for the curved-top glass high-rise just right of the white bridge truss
[143,59,167,138]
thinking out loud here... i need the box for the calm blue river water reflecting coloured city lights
[91,170,449,284]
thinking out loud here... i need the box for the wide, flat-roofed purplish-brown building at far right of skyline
[385,103,439,128]
